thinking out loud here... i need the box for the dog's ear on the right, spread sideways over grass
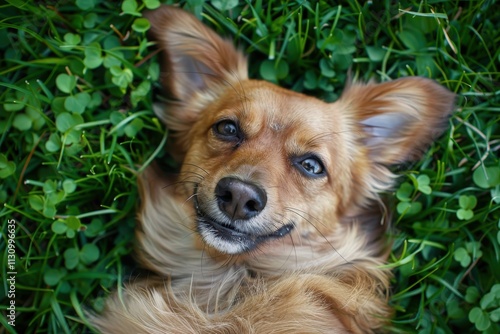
[339,77,455,165]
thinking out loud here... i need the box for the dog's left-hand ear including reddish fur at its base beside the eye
[144,6,248,136]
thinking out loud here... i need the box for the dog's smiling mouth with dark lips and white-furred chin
[194,196,295,254]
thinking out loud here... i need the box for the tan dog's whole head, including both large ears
[147,6,454,254]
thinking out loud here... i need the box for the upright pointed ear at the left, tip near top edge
[144,5,247,101]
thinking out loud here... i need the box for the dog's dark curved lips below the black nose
[194,192,295,251]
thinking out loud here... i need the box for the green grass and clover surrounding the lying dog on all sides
[0,0,500,333]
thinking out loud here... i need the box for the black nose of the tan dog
[215,177,267,220]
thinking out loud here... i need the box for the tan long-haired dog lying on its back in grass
[92,6,455,333]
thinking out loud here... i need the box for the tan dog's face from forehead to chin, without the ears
[181,80,351,254]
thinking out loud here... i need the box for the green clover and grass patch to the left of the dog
[0,0,164,333]
